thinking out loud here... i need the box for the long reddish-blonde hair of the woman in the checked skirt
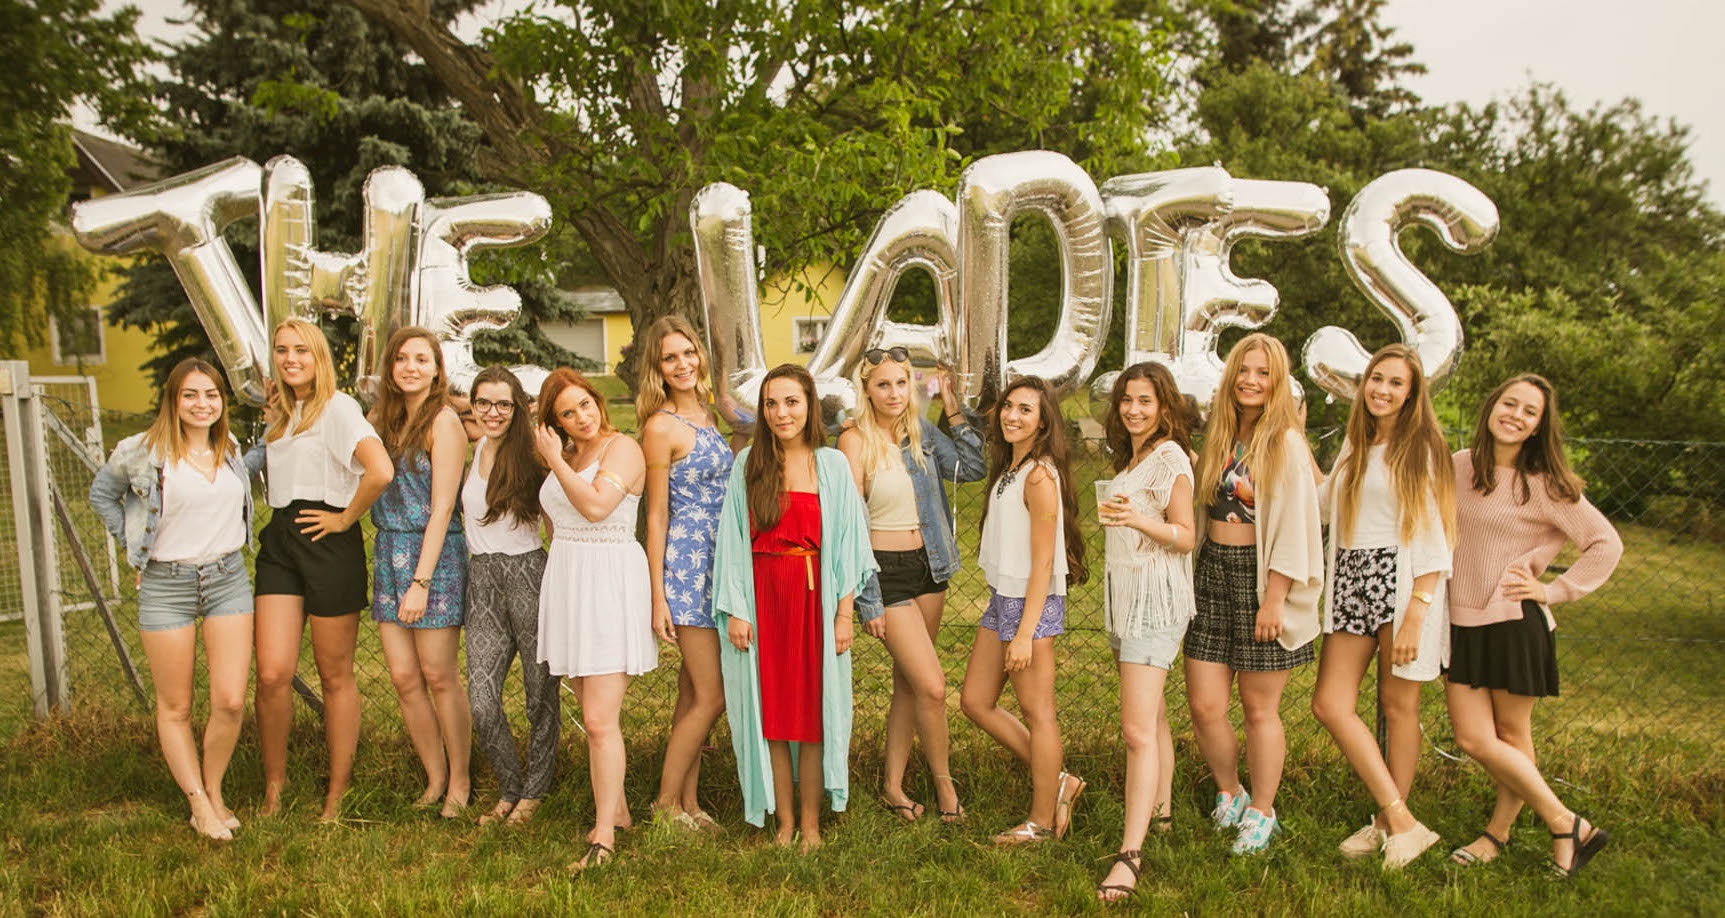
[1194,331,1306,506]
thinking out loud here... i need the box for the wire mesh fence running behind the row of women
[0,400,1725,790]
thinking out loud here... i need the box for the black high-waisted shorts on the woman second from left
[254,500,371,618]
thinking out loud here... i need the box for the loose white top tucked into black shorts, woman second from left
[266,392,381,509]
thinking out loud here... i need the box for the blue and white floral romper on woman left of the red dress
[659,409,735,628]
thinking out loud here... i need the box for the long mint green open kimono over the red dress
[712,447,876,827]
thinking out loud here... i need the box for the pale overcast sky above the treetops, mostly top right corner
[104,0,1725,204]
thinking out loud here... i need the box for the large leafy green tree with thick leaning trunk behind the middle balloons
[336,0,1166,380]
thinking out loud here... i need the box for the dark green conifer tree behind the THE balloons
[112,0,581,383]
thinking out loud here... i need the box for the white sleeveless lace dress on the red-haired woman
[538,459,659,676]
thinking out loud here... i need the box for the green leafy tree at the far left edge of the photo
[0,0,155,352]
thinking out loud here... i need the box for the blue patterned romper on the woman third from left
[371,450,467,628]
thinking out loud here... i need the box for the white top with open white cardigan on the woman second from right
[1318,443,1451,682]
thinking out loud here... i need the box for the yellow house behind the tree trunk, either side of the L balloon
[540,266,845,373]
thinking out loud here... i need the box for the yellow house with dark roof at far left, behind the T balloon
[24,131,155,414]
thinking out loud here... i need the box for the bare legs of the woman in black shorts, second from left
[254,594,359,820]
